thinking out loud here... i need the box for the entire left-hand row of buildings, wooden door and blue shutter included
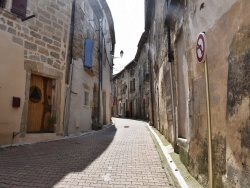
[0,0,115,145]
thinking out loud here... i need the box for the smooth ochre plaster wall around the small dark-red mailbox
[0,30,26,145]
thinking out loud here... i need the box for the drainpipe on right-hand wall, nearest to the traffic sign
[167,26,178,153]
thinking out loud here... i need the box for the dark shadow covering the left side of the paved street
[0,126,117,187]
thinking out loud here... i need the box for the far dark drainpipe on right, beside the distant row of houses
[148,31,154,126]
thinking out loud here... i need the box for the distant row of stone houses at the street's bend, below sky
[112,33,149,120]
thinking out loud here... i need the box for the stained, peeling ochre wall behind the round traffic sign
[184,1,250,187]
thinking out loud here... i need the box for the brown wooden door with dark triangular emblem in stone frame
[27,75,54,133]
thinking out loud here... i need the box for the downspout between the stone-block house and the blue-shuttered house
[63,0,76,136]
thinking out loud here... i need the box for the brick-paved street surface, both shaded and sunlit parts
[0,119,177,188]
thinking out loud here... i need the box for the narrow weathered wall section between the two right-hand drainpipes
[146,0,173,142]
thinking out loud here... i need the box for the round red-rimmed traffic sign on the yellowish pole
[196,33,206,63]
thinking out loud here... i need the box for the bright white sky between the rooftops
[106,0,145,74]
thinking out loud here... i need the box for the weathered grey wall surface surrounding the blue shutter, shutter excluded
[68,0,99,134]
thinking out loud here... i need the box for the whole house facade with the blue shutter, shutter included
[65,0,115,134]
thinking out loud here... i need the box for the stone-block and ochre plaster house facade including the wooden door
[0,0,71,145]
